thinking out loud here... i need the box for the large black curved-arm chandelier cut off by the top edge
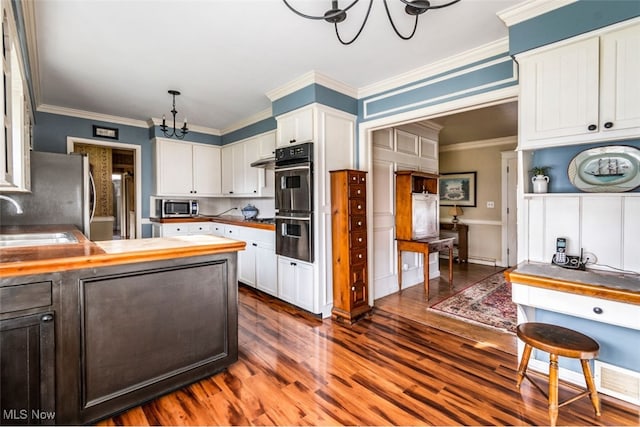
[282,0,460,45]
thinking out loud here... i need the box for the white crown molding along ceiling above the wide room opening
[358,37,509,99]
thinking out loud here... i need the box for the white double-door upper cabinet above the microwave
[153,138,221,197]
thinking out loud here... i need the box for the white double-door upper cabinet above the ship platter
[518,23,640,149]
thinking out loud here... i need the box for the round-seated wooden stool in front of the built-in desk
[516,322,600,426]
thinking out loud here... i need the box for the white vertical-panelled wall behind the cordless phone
[523,193,640,271]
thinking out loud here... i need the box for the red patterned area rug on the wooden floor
[429,271,517,333]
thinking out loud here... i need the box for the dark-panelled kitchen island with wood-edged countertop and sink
[0,226,245,424]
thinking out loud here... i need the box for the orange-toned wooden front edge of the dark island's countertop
[0,241,246,277]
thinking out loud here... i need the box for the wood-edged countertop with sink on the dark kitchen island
[0,225,246,277]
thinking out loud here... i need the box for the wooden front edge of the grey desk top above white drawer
[504,270,640,304]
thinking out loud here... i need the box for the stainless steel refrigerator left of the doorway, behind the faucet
[0,151,95,238]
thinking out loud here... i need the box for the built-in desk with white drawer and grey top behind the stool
[505,262,640,404]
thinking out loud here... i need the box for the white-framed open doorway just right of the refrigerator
[67,137,141,241]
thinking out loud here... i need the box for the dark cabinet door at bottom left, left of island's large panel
[0,313,56,425]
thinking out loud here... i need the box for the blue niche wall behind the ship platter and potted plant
[533,139,640,193]
